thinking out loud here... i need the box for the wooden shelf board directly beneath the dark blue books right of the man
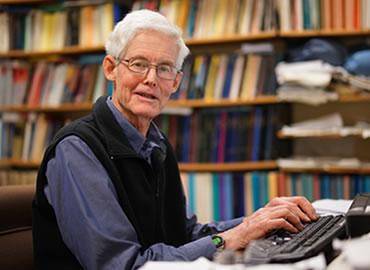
[179,161,277,172]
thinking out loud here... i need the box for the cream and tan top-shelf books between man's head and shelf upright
[132,0,276,38]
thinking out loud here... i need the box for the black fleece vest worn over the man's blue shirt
[33,97,190,269]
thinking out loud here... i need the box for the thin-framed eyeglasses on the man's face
[118,58,179,80]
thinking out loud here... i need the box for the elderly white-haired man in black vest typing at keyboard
[33,10,316,270]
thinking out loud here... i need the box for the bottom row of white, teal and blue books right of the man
[182,171,370,222]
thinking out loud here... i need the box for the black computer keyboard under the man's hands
[243,215,345,264]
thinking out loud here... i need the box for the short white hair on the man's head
[105,9,189,69]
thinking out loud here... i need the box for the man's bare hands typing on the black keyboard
[220,196,317,250]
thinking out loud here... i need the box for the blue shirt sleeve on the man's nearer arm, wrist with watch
[44,136,215,270]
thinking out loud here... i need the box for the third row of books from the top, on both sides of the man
[0,105,286,163]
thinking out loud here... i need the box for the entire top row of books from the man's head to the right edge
[133,0,370,38]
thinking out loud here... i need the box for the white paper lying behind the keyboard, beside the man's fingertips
[312,199,352,215]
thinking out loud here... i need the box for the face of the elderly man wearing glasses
[107,31,181,122]
